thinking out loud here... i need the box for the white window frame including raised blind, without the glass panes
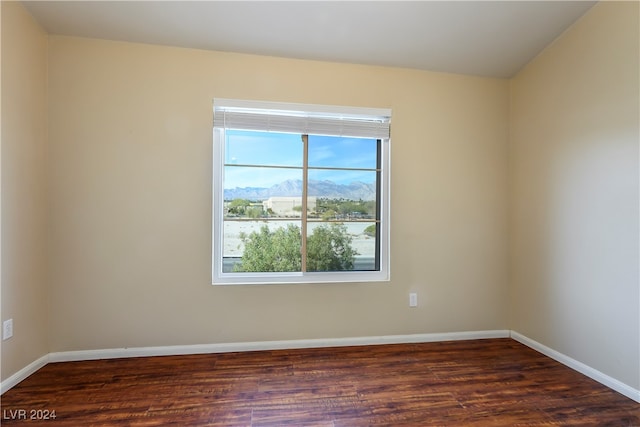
[212,98,391,285]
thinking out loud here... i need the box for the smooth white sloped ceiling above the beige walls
[25,0,595,77]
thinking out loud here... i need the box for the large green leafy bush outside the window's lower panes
[234,224,358,272]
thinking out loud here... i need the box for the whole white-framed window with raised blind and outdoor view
[212,99,390,284]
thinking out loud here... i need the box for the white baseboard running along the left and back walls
[0,330,509,394]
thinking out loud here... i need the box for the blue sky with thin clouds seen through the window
[224,131,377,188]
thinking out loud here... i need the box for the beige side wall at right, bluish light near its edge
[510,2,640,389]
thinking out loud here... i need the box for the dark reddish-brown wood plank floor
[1,339,640,427]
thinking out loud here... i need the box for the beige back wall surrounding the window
[49,36,509,352]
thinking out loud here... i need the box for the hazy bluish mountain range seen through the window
[224,179,376,200]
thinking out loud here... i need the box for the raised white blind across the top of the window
[213,99,391,139]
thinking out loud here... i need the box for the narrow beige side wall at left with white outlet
[0,1,49,380]
